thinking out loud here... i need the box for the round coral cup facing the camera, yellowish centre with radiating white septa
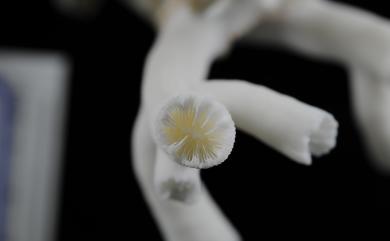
[155,94,236,168]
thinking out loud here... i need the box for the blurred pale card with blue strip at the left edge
[0,50,69,241]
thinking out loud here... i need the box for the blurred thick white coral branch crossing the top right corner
[248,0,390,74]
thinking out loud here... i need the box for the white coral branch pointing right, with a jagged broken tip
[197,80,338,165]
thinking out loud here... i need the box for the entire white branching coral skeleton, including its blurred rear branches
[55,0,390,241]
